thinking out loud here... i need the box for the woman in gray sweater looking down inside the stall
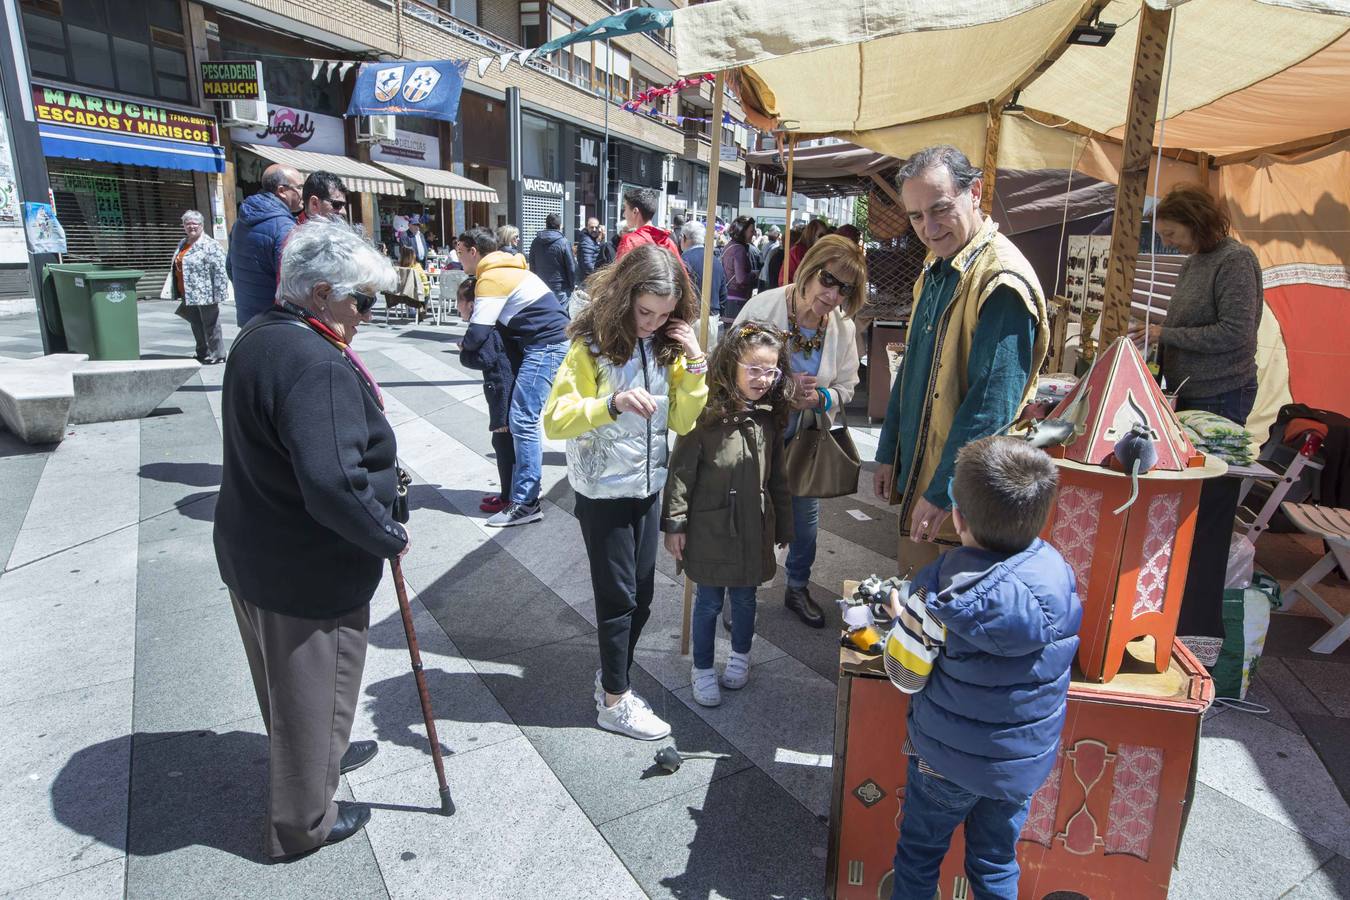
[1131,185,1262,425]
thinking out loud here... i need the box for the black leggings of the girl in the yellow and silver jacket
[576,493,662,694]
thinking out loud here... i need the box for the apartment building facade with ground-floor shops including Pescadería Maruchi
[7,0,749,290]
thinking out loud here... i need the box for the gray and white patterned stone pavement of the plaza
[0,302,1350,900]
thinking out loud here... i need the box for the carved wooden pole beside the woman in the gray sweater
[1100,4,1172,347]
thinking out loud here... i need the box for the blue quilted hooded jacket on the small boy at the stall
[909,538,1083,803]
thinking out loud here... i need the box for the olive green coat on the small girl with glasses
[662,405,792,587]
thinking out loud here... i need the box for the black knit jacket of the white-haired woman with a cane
[215,309,408,619]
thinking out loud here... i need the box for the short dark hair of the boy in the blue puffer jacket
[952,436,1060,553]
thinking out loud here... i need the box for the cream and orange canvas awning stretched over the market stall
[675,0,1350,179]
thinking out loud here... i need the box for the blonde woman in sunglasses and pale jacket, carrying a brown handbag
[736,235,867,627]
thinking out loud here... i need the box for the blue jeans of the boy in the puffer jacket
[891,756,1031,900]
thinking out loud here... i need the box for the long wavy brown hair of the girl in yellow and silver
[567,244,698,366]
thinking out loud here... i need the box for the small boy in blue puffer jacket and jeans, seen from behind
[884,437,1083,900]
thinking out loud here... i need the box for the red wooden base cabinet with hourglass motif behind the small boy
[826,638,1214,900]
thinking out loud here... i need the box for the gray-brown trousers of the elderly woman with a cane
[230,591,370,857]
